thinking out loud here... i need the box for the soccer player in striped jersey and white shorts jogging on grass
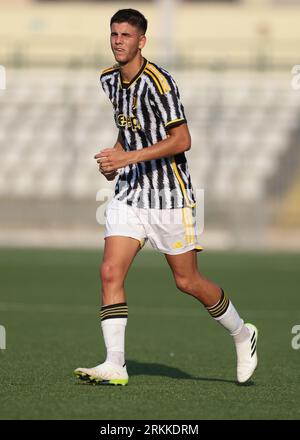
[74,9,257,385]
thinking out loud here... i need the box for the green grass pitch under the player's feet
[0,249,300,420]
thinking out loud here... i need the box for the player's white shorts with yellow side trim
[104,199,203,255]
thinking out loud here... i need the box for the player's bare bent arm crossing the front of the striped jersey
[95,123,191,171]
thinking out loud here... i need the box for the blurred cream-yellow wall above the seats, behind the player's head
[0,1,300,69]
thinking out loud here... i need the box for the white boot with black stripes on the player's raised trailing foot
[235,323,258,383]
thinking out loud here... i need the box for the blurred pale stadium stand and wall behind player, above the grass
[0,0,300,250]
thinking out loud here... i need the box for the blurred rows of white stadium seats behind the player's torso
[0,69,300,206]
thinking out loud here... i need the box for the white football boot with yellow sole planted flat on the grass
[74,361,128,385]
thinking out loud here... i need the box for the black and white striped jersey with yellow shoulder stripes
[100,60,195,209]
